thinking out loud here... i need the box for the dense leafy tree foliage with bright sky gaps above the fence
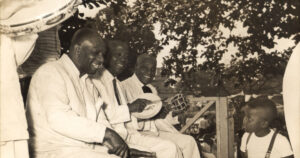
[59,0,300,93]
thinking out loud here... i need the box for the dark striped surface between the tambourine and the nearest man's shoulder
[18,26,61,78]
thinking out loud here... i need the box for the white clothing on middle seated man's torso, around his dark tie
[93,70,131,140]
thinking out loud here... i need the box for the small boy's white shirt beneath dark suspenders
[240,130,293,158]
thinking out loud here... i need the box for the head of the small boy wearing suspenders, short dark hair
[243,97,277,132]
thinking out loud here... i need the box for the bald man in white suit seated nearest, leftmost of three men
[27,28,128,158]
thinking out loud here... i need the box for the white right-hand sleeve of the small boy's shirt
[274,134,293,157]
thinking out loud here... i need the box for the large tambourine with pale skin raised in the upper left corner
[0,0,80,36]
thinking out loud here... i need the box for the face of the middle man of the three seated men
[107,45,129,76]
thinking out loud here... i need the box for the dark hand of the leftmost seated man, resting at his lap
[103,128,129,158]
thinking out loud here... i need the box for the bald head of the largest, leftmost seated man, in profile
[69,28,106,74]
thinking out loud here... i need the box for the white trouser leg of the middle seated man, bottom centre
[126,133,183,158]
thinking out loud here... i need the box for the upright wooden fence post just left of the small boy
[216,97,234,158]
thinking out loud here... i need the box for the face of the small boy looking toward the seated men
[243,108,265,132]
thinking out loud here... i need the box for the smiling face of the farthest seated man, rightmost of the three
[135,60,156,85]
